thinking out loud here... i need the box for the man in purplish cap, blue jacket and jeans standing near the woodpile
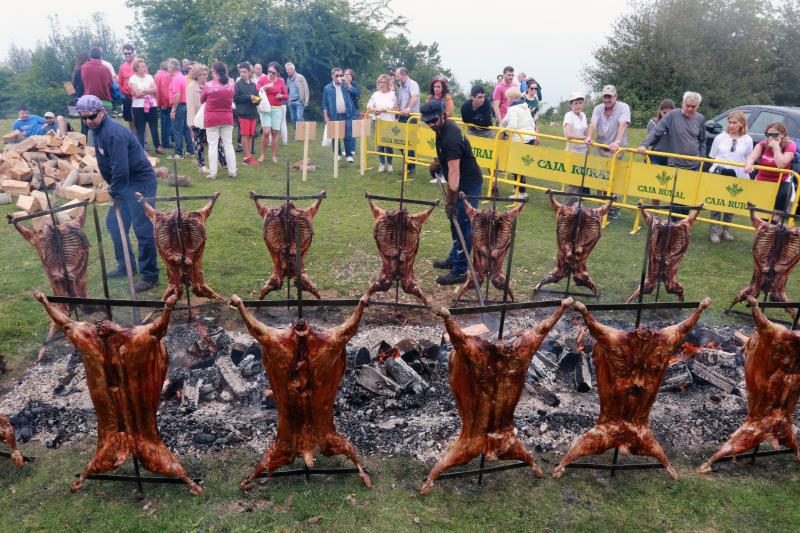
[75,95,158,292]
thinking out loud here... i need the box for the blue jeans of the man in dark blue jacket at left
[106,179,158,283]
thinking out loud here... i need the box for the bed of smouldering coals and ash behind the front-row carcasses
[0,310,792,461]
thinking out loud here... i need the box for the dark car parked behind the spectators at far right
[704,105,800,172]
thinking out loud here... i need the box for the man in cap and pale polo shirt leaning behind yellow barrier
[584,85,631,220]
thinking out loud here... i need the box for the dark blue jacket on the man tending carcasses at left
[94,116,156,198]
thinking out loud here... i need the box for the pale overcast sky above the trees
[0,0,628,105]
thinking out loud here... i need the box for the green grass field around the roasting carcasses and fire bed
[0,121,800,531]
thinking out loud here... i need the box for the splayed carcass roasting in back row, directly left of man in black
[367,194,436,305]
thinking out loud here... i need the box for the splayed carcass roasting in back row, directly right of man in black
[456,193,525,300]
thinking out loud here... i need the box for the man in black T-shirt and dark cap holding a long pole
[420,102,483,285]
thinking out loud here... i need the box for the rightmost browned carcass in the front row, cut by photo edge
[698,296,800,473]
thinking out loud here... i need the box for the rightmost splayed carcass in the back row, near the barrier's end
[728,203,800,316]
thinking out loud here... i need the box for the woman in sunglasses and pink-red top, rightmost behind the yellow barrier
[744,122,797,211]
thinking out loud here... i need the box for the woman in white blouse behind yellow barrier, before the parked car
[708,111,753,244]
